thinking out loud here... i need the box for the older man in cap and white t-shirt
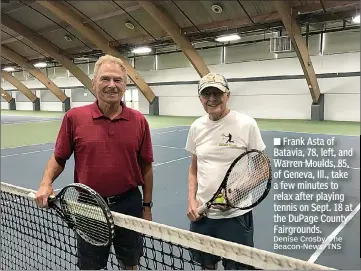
[186,73,266,270]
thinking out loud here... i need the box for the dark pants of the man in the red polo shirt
[77,188,143,270]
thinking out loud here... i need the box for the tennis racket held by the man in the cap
[198,150,272,215]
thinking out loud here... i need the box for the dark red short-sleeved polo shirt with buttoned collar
[54,102,153,197]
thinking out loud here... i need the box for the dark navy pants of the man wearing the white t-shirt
[190,211,254,270]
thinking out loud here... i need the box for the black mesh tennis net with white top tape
[0,182,331,270]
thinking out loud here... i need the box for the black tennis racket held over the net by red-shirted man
[36,183,114,246]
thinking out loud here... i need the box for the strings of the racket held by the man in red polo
[62,188,109,244]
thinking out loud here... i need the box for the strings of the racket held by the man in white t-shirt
[225,153,270,208]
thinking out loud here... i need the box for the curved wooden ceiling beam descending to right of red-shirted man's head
[37,1,155,103]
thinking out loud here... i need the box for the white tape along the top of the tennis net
[1,182,334,270]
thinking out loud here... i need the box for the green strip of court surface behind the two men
[1,110,360,148]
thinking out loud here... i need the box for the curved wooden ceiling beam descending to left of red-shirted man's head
[1,14,95,96]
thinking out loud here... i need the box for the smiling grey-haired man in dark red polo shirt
[35,55,153,270]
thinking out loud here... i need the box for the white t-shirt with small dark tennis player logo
[185,110,266,219]
